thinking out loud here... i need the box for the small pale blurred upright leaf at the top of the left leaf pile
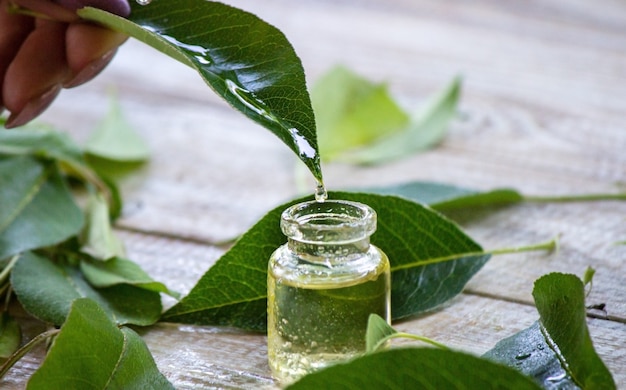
[84,90,150,162]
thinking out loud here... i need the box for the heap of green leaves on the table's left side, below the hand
[0,101,175,389]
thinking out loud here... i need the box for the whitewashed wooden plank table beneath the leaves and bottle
[0,0,626,389]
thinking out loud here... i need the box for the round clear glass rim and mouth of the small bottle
[280,200,376,243]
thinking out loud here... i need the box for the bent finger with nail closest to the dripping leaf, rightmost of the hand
[64,23,128,88]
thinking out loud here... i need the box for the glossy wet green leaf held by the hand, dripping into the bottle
[78,0,322,182]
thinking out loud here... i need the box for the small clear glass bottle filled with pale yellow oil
[268,200,391,382]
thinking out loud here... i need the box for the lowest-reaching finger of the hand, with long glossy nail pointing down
[2,19,69,127]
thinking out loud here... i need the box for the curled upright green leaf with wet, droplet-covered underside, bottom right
[485,273,616,390]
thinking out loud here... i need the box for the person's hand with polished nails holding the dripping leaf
[0,0,130,128]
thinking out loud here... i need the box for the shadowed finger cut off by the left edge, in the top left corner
[0,0,34,112]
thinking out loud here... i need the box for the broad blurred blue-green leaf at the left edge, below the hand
[0,155,83,259]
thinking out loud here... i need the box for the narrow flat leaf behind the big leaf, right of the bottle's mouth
[359,181,524,212]
